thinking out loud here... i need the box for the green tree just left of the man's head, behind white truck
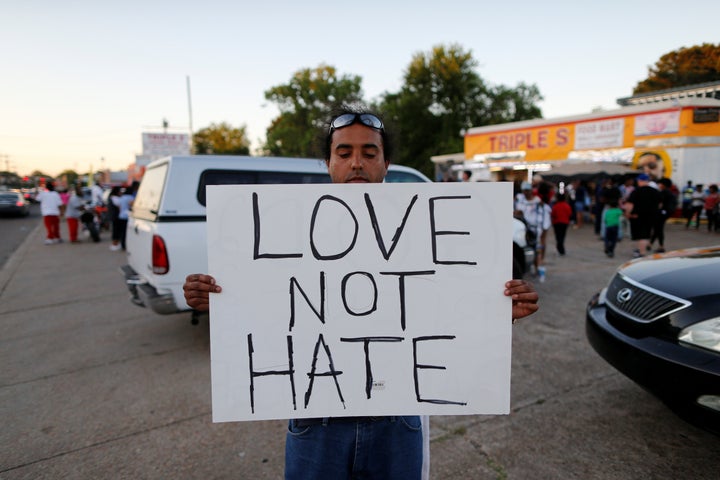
[263,64,362,157]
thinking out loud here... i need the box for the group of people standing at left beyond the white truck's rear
[35,182,138,251]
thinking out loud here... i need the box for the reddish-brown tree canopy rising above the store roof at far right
[633,43,720,94]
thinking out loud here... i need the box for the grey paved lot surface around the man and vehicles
[0,219,720,480]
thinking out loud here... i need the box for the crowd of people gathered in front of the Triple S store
[514,169,720,282]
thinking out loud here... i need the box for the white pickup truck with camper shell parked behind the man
[122,155,430,324]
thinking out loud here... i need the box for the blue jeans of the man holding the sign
[285,417,423,480]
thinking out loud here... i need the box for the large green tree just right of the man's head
[378,45,542,175]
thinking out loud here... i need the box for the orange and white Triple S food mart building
[432,89,720,185]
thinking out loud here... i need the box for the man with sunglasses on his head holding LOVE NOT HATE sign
[183,109,538,479]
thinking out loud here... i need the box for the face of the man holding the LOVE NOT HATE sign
[327,123,390,183]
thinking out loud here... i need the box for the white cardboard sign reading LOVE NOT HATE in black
[207,183,512,422]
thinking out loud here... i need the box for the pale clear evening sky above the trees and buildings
[0,0,720,175]
